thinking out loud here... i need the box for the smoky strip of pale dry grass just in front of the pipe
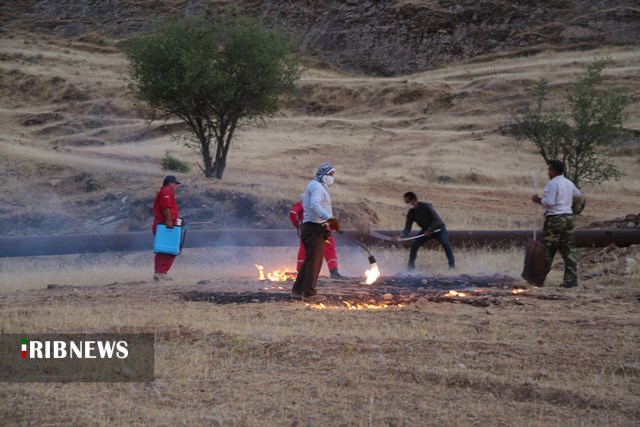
[0,244,523,292]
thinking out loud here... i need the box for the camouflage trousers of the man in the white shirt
[542,215,578,284]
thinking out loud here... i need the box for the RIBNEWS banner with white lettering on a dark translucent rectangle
[0,334,155,382]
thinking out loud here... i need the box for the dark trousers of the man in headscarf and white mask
[293,222,325,297]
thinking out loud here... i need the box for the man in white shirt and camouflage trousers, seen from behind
[531,160,582,288]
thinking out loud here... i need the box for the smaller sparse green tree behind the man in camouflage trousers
[515,59,628,186]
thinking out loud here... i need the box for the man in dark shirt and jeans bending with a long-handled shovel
[400,191,456,271]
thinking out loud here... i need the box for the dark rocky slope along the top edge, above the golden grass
[0,0,640,75]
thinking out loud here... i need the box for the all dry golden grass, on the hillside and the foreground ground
[0,26,640,426]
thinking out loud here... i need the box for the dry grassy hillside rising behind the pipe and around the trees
[0,0,640,234]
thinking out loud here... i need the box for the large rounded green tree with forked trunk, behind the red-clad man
[124,14,302,178]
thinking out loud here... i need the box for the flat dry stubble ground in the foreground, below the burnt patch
[0,266,640,426]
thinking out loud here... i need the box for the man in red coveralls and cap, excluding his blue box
[152,175,180,281]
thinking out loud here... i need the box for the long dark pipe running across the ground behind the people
[0,229,640,257]
